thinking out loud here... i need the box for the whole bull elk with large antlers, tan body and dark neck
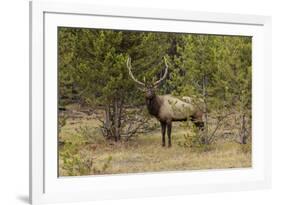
[127,58,204,147]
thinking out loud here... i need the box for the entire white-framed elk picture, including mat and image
[30,1,271,204]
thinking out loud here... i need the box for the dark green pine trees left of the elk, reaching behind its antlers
[59,28,173,141]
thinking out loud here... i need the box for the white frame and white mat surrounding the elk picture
[30,1,271,204]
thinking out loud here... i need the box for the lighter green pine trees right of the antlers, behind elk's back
[169,34,252,144]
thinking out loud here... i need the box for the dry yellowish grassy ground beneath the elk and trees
[59,114,251,176]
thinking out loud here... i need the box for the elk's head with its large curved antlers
[127,57,168,99]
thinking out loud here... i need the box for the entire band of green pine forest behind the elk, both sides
[58,27,252,175]
